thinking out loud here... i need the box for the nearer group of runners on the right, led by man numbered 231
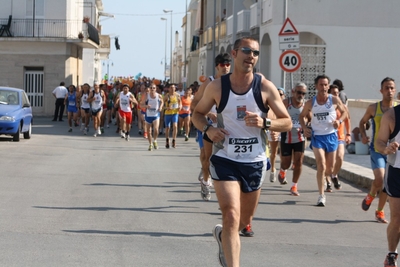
[192,37,400,267]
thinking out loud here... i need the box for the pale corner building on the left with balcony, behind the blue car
[0,0,110,115]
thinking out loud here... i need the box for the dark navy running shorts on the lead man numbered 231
[210,155,266,193]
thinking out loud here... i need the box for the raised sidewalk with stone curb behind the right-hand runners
[304,148,374,189]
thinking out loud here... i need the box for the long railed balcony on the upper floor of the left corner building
[0,18,100,48]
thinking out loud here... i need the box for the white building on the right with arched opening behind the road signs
[182,0,400,99]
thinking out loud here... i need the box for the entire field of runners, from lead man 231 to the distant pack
[54,37,400,266]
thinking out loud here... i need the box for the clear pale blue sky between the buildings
[100,0,190,79]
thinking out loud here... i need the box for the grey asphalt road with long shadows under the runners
[0,118,389,267]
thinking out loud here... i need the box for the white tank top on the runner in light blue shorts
[311,95,336,135]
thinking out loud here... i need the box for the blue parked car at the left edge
[0,87,33,142]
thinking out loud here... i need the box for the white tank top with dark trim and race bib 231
[215,89,266,163]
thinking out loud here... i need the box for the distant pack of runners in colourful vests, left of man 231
[63,78,198,148]
